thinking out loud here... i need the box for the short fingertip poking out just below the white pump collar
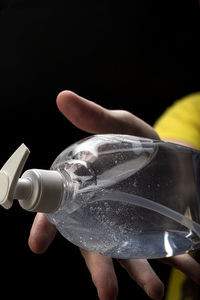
[28,213,57,254]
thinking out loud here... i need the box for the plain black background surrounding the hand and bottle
[0,0,200,299]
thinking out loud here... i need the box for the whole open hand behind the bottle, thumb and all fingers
[29,91,200,300]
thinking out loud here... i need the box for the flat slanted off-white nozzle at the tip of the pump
[0,144,30,209]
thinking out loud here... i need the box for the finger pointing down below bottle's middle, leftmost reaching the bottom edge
[80,249,118,300]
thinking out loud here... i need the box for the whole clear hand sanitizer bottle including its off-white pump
[0,134,200,258]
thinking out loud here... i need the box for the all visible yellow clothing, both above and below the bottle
[154,92,200,300]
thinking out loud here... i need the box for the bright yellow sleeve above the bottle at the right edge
[154,92,200,150]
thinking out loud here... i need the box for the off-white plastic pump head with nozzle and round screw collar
[0,144,64,213]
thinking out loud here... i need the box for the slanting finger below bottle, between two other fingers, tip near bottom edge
[118,259,164,300]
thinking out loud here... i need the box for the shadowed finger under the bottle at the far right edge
[161,254,200,284]
